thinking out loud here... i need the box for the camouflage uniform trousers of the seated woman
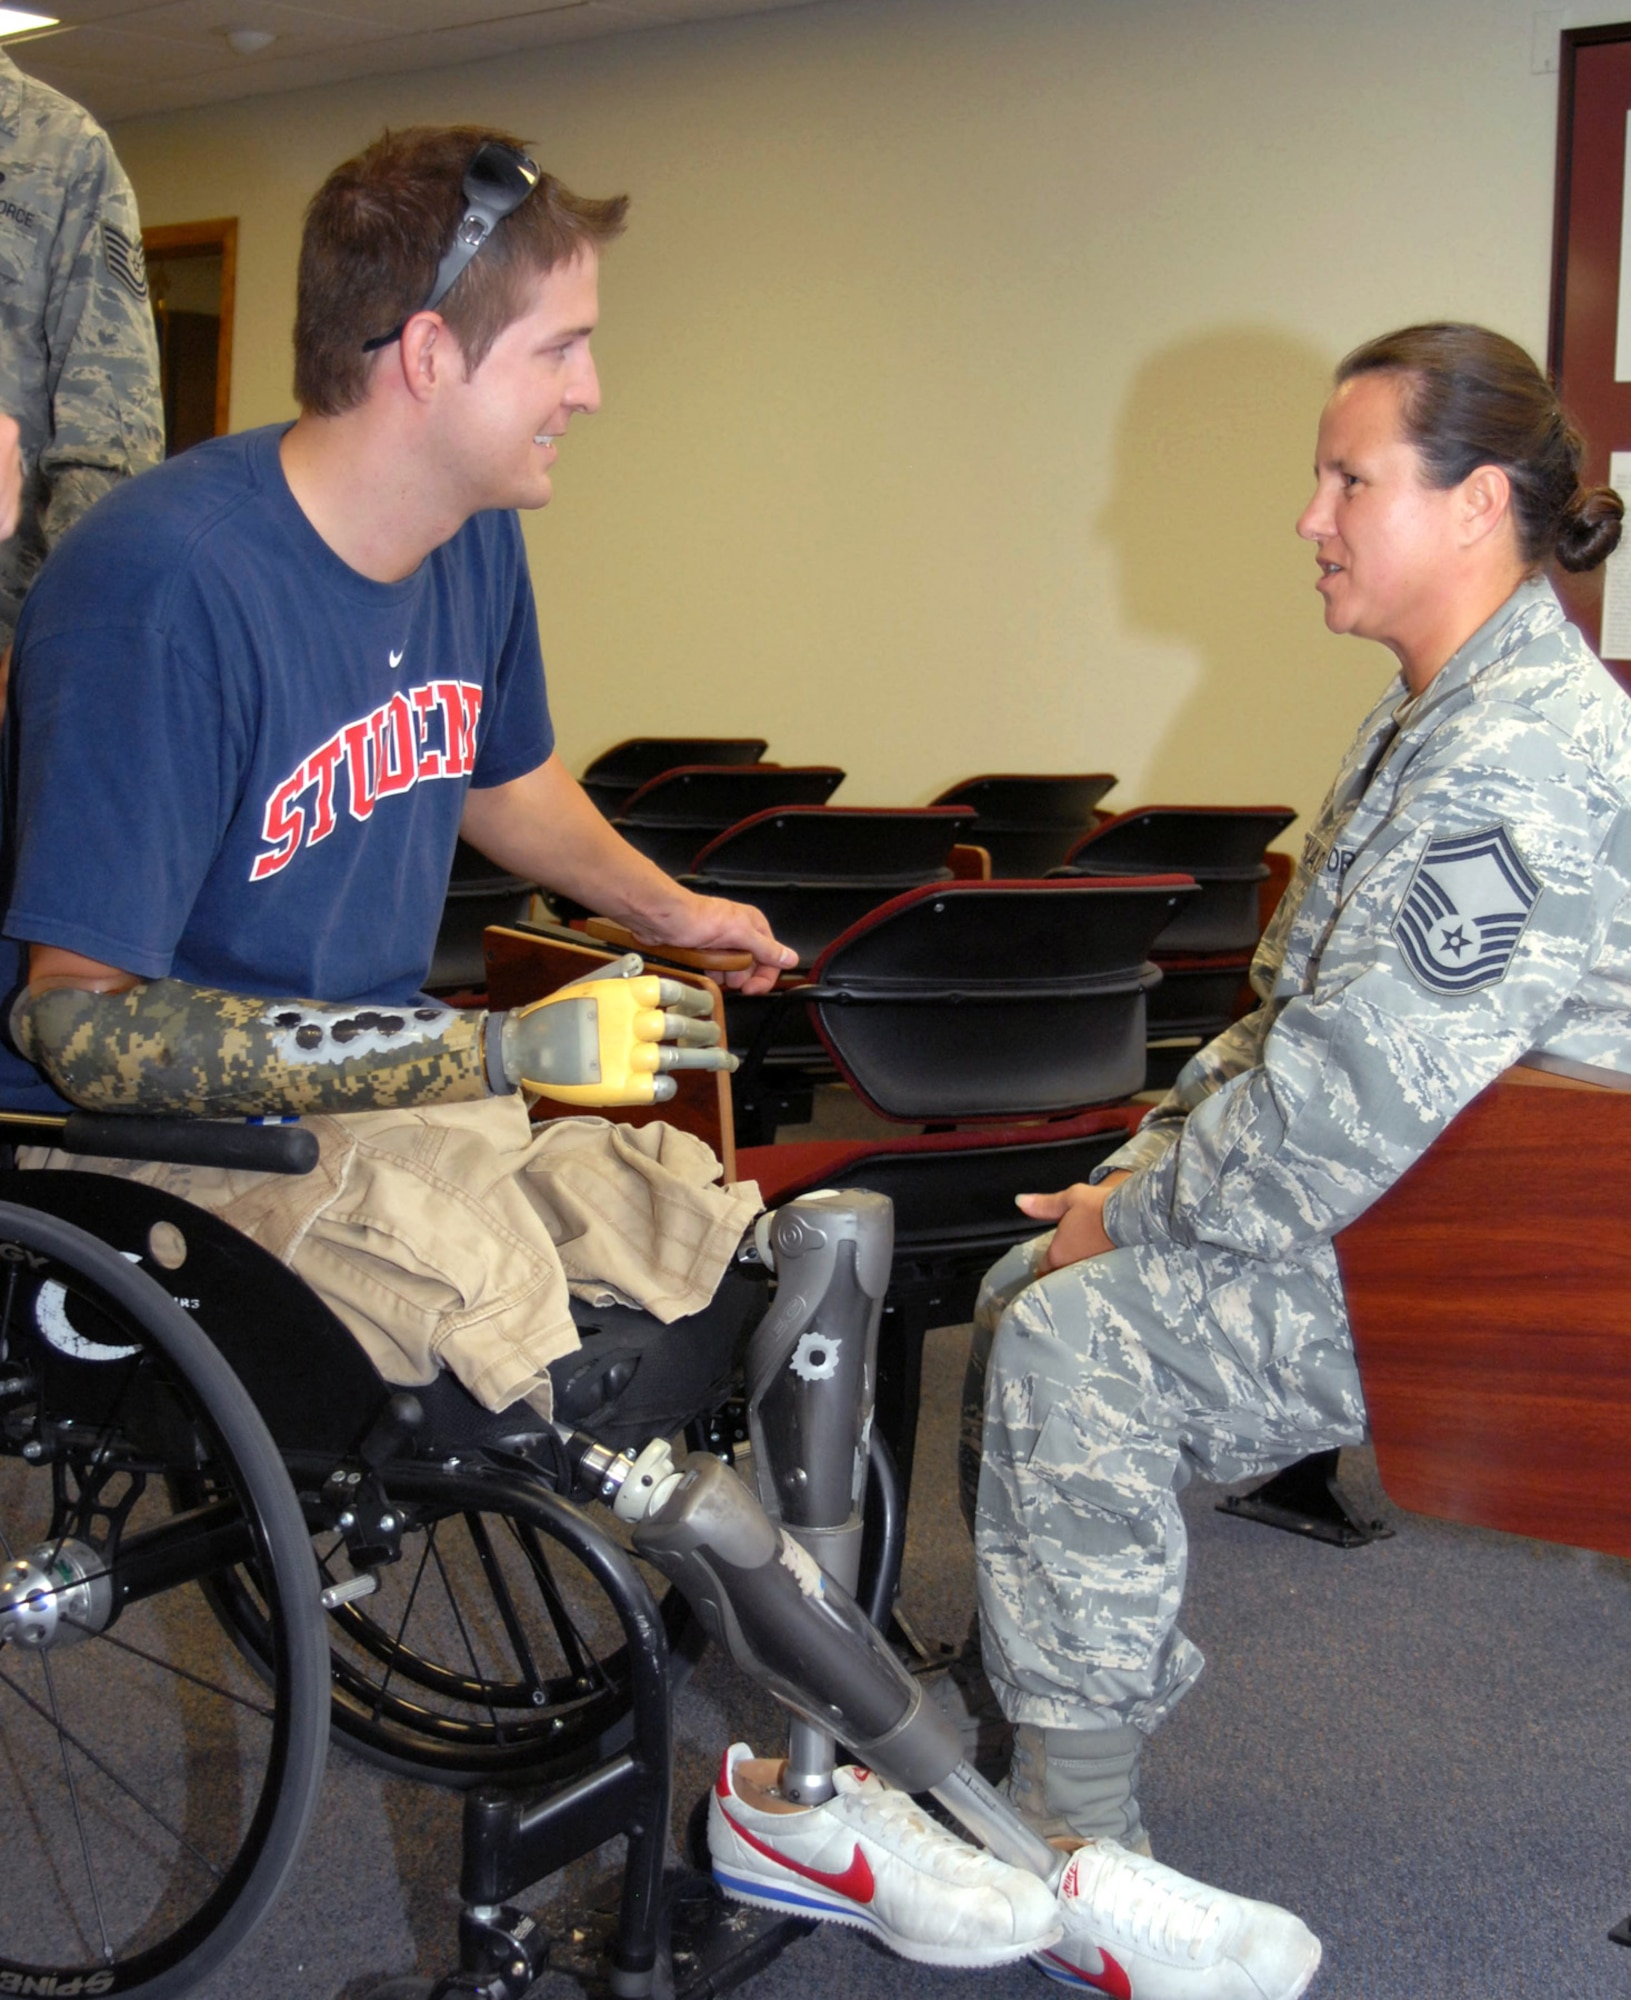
[969,1238,1365,1732]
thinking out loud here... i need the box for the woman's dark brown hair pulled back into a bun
[1337,320,1625,570]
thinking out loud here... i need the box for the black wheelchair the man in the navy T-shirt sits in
[0,1114,931,2000]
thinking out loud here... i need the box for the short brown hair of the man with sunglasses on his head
[294,126,628,416]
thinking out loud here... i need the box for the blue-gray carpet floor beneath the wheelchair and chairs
[168,1328,1631,2000]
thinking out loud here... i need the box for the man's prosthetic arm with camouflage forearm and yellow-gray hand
[12,954,736,1118]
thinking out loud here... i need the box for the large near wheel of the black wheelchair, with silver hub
[0,1204,328,2000]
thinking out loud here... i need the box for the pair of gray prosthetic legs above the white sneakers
[574,1192,1063,1882]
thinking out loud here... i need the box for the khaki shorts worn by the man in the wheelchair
[20,1096,762,1416]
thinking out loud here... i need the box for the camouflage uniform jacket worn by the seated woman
[1099,582,1631,1258]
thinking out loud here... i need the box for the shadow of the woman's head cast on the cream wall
[1099,328,1389,814]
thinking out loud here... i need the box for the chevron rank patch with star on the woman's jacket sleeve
[1393,826,1541,994]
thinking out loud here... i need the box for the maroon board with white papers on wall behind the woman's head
[1547,22,1631,688]
